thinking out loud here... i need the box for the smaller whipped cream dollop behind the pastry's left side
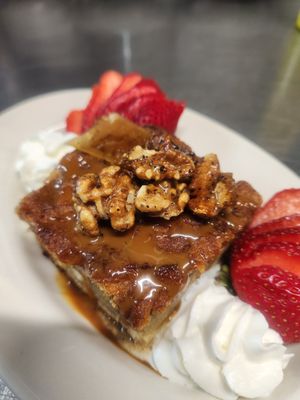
[16,129,77,192]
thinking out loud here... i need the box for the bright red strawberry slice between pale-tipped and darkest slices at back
[99,79,164,115]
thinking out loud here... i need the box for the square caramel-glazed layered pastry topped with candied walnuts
[17,115,261,352]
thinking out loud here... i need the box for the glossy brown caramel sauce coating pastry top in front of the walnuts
[24,146,256,331]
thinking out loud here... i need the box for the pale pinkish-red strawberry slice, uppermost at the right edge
[250,189,300,227]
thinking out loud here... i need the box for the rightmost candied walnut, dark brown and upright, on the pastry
[188,154,234,218]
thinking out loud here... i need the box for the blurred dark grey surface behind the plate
[0,0,300,174]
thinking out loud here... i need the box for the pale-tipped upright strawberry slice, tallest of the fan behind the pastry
[83,71,123,131]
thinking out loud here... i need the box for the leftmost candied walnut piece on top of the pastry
[74,165,136,235]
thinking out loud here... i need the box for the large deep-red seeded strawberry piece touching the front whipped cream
[231,241,300,343]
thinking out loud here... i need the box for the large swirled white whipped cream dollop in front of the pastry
[152,267,292,400]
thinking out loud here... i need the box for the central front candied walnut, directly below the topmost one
[135,181,189,219]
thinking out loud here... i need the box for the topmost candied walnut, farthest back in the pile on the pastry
[122,146,195,181]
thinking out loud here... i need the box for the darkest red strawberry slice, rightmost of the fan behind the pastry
[133,98,184,133]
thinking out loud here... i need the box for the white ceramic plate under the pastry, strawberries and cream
[0,89,300,400]
